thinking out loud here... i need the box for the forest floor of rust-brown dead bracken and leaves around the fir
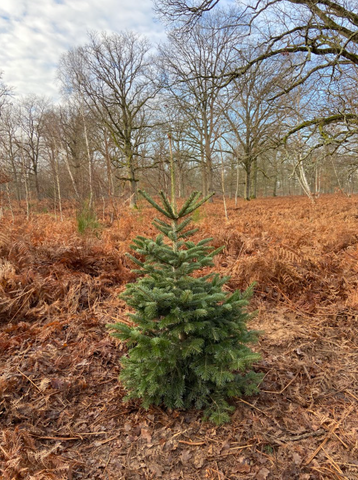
[0,195,358,480]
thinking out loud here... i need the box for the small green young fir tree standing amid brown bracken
[108,191,262,424]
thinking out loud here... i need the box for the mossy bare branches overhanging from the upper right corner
[157,0,358,135]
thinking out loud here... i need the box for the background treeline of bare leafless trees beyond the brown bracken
[0,0,358,214]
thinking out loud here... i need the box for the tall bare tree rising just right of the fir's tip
[160,16,242,194]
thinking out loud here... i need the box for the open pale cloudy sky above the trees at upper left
[0,0,164,100]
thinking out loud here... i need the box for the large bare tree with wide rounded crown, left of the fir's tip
[60,33,157,206]
